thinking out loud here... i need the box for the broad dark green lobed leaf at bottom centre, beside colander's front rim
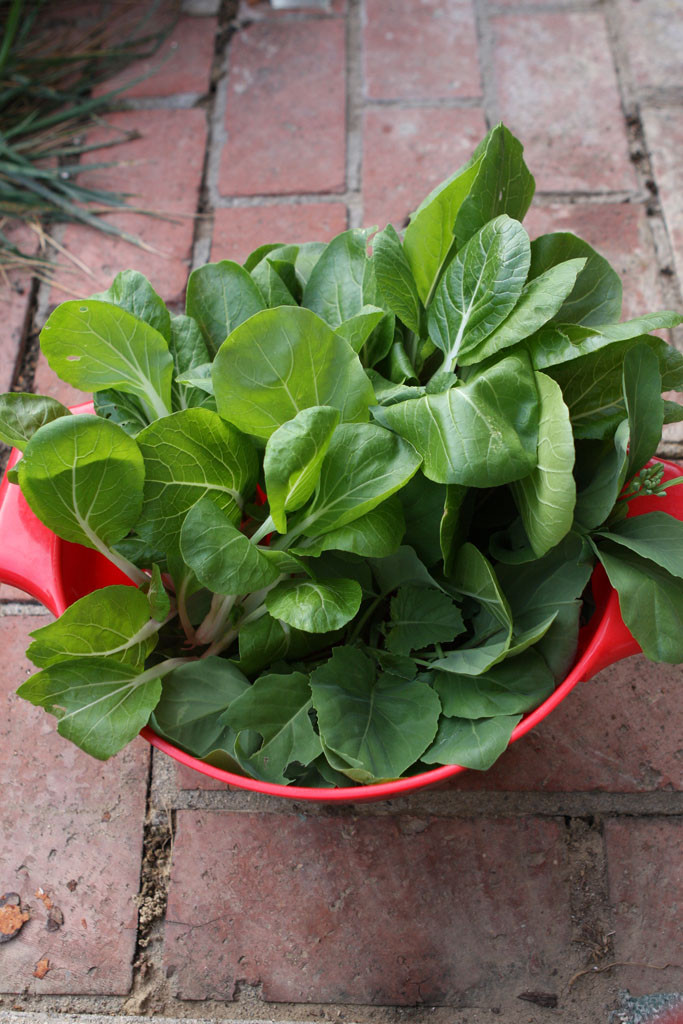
[310,647,440,782]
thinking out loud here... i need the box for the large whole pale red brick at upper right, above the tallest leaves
[492,11,635,191]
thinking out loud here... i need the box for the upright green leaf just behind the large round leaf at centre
[302,228,370,325]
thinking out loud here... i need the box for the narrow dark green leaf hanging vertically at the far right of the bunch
[622,345,664,477]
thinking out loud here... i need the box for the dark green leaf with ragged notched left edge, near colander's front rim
[223,672,322,785]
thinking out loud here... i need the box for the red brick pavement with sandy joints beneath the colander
[0,0,683,1024]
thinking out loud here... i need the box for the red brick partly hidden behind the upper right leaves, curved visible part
[524,203,663,319]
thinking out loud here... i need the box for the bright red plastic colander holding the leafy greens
[0,402,683,803]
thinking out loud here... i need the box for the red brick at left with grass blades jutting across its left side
[50,110,207,305]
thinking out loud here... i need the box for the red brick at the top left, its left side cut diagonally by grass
[94,15,218,99]
